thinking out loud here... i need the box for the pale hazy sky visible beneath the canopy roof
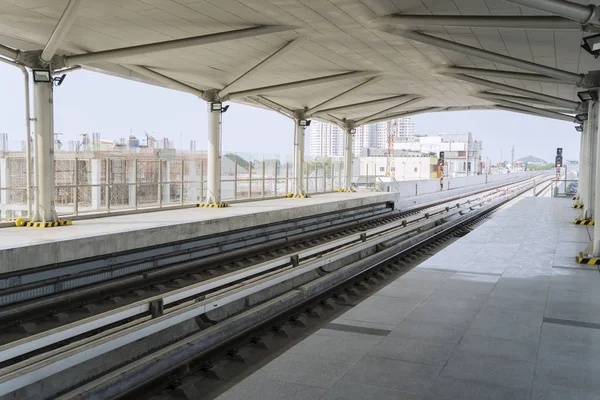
[0,64,579,162]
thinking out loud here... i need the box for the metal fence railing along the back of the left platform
[0,153,344,219]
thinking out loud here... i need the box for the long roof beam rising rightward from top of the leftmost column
[64,25,294,66]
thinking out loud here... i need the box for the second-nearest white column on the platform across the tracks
[205,103,221,204]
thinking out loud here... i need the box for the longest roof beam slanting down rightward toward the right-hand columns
[377,26,584,84]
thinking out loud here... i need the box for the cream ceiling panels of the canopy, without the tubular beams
[0,0,598,122]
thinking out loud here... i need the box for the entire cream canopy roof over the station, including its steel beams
[0,0,599,125]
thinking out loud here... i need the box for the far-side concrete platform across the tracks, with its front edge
[0,192,396,273]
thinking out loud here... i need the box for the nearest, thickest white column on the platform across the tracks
[32,77,58,222]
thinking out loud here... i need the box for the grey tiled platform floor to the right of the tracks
[218,197,600,400]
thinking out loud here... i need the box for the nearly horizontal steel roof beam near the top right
[373,14,581,31]
